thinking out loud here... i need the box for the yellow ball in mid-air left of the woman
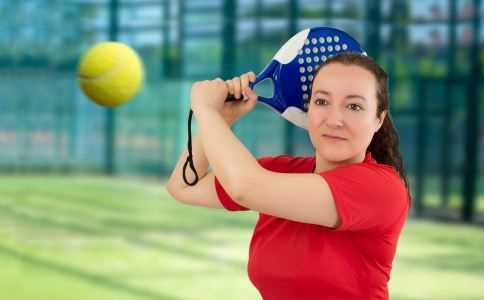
[78,42,144,107]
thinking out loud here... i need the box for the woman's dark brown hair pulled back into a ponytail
[313,52,411,199]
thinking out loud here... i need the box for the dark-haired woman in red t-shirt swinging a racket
[167,53,410,300]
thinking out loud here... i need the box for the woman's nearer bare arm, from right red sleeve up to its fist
[192,80,339,227]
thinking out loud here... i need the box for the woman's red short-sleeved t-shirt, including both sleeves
[215,153,409,300]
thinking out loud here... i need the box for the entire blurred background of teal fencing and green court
[0,0,484,299]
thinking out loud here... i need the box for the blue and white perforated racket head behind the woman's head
[254,27,366,128]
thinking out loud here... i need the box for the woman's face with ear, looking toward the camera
[308,63,386,163]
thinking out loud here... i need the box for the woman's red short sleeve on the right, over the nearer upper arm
[319,163,409,233]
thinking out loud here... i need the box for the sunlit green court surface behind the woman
[0,175,484,300]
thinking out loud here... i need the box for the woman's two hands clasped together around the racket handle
[191,72,257,126]
